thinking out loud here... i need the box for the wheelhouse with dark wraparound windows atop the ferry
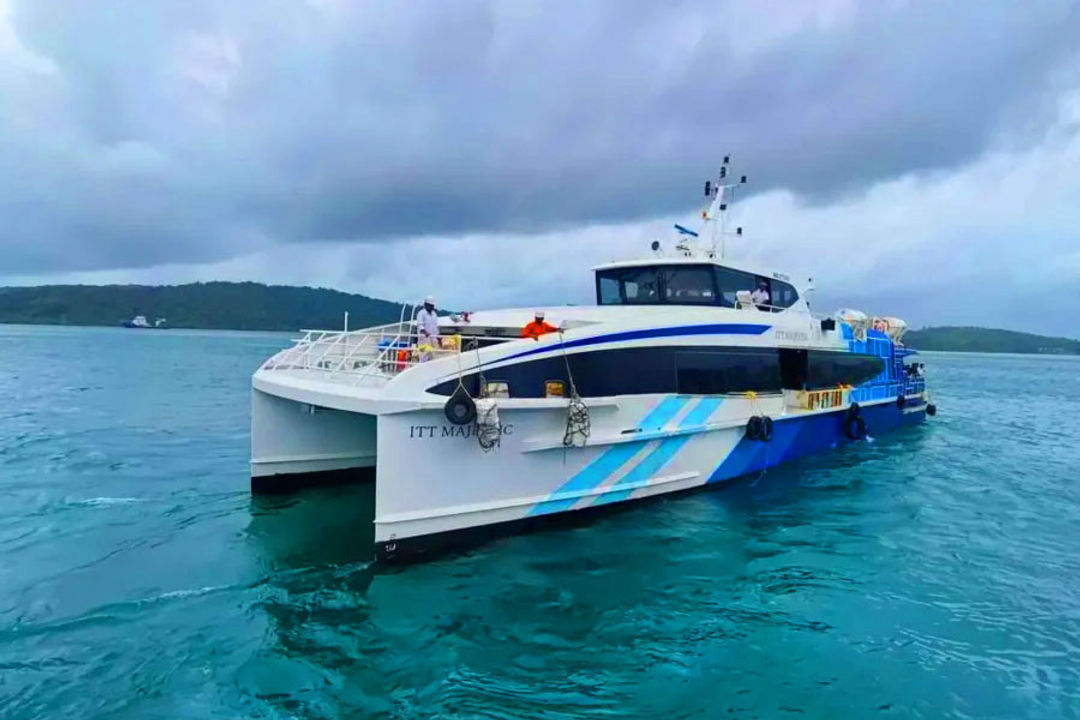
[596,261,799,312]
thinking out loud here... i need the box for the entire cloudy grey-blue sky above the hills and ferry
[0,0,1080,336]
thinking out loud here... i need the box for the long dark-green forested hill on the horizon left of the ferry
[0,283,401,330]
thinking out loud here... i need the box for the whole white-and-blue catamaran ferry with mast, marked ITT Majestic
[251,159,935,560]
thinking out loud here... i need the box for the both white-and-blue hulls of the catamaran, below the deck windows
[252,390,926,559]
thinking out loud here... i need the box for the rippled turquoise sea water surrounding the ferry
[0,326,1080,720]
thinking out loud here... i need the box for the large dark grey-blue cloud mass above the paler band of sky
[0,0,1080,274]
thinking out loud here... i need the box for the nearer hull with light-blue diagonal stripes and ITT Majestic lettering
[375,395,924,559]
